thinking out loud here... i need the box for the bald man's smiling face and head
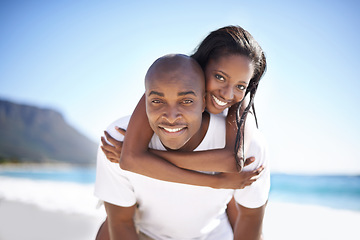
[145,55,205,150]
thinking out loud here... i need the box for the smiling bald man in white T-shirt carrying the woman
[95,55,269,239]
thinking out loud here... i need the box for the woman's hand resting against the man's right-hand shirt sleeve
[220,157,264,189]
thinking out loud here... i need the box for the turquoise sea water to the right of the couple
[269,174,360,211]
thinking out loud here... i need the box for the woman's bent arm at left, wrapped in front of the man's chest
[120,96,224,188]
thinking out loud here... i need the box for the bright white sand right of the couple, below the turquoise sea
[263,201,360,240]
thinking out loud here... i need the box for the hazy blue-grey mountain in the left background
[0,99,97,164]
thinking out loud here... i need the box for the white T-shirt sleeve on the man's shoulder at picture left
[94,117,136,207]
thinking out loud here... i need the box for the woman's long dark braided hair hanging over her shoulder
[191,26,266,172]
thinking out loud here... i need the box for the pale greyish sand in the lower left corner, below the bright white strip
[0,200,104,240]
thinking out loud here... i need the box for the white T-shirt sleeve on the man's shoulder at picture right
[234,131,270,208]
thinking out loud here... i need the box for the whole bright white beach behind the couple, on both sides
[0,173,360,240]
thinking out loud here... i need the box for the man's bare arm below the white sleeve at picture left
[105,202,139,240]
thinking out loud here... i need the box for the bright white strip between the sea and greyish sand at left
[0,177,105,216]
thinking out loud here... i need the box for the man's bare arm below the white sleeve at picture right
[234,203,266,240]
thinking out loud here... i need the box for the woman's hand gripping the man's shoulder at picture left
[101,127,126,163]
